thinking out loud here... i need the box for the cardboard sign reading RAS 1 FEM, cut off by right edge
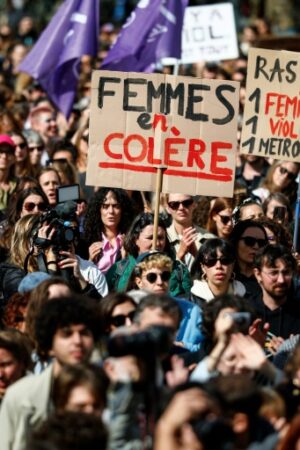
[241,48,300,162]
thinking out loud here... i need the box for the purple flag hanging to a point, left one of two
[19,0,99,117]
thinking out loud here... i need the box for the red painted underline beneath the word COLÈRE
[99,162,232,182]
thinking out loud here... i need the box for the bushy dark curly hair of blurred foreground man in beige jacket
[35,294,99,356]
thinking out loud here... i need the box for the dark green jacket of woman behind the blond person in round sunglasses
[106,255,193,298]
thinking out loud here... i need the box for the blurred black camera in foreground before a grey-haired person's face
[107,325,174,360]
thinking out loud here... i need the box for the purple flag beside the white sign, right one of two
[101,0,188,72]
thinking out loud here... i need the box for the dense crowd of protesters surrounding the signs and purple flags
[0,1,300,450]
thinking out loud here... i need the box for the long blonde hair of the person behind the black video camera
[9,214,39,272]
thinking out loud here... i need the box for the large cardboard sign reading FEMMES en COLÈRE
[87,71,239,197]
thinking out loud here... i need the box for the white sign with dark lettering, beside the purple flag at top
[181,3,239,64]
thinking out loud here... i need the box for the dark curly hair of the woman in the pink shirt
[84,187,133,245]
